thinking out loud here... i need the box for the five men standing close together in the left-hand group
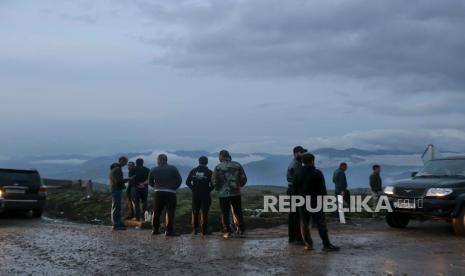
[109,150,247,239]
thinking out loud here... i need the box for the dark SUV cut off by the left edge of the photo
[0,169,47,217]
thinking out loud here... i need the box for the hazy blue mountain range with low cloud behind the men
[0,148,436,189]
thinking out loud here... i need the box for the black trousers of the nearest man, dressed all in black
[299,206,331,246]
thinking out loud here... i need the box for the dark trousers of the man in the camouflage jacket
[220,195,245,233]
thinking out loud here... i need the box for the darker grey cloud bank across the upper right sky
[134,0,465,92]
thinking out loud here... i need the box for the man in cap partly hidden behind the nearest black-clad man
[286,146,307,243]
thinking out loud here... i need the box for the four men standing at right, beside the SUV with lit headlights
[287,146,382,251]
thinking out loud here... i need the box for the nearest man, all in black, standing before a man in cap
[293,153,339,251]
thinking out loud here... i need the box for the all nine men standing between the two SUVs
[109,146,382,251]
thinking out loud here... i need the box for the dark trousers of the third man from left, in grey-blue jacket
[152,192,176,233]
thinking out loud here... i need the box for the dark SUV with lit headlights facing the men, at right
[384,156,465,236]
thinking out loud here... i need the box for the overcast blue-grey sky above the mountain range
[0,0,465,158]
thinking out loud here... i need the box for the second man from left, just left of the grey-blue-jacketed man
[131,158,150,221]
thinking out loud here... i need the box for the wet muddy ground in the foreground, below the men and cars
[0,215,465,275]
